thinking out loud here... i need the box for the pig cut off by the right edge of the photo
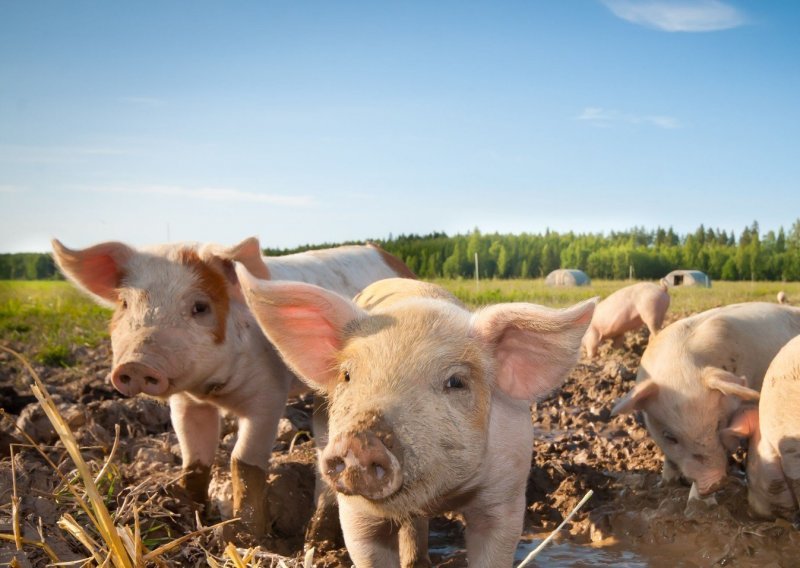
[724,336,800,520]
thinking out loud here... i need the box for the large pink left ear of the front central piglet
[236,265,366,389]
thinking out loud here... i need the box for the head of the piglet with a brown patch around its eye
[53,239,268,397]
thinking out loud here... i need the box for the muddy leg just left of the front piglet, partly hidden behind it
[305,393,344,550]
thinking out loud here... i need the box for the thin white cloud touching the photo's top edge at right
[602,0,747,32]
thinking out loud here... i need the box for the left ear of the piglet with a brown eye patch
[51,239,136,306]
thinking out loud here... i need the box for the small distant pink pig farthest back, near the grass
[583,279,669,358]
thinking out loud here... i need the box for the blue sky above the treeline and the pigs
[0,0,800,252]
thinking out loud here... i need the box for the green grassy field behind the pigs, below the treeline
[0,279,800,366]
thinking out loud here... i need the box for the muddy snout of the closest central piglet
[322,432,403,499]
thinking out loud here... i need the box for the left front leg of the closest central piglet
[339,496,400,568]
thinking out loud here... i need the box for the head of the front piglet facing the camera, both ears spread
[239,271,593,519]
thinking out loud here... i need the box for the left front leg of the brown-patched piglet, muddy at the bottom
[169,393,220,503]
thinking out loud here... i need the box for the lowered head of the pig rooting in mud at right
[612,359,758,495]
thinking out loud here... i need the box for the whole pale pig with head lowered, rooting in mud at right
[612,302,800,497]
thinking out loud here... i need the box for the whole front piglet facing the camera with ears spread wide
[237,272,594,568]
